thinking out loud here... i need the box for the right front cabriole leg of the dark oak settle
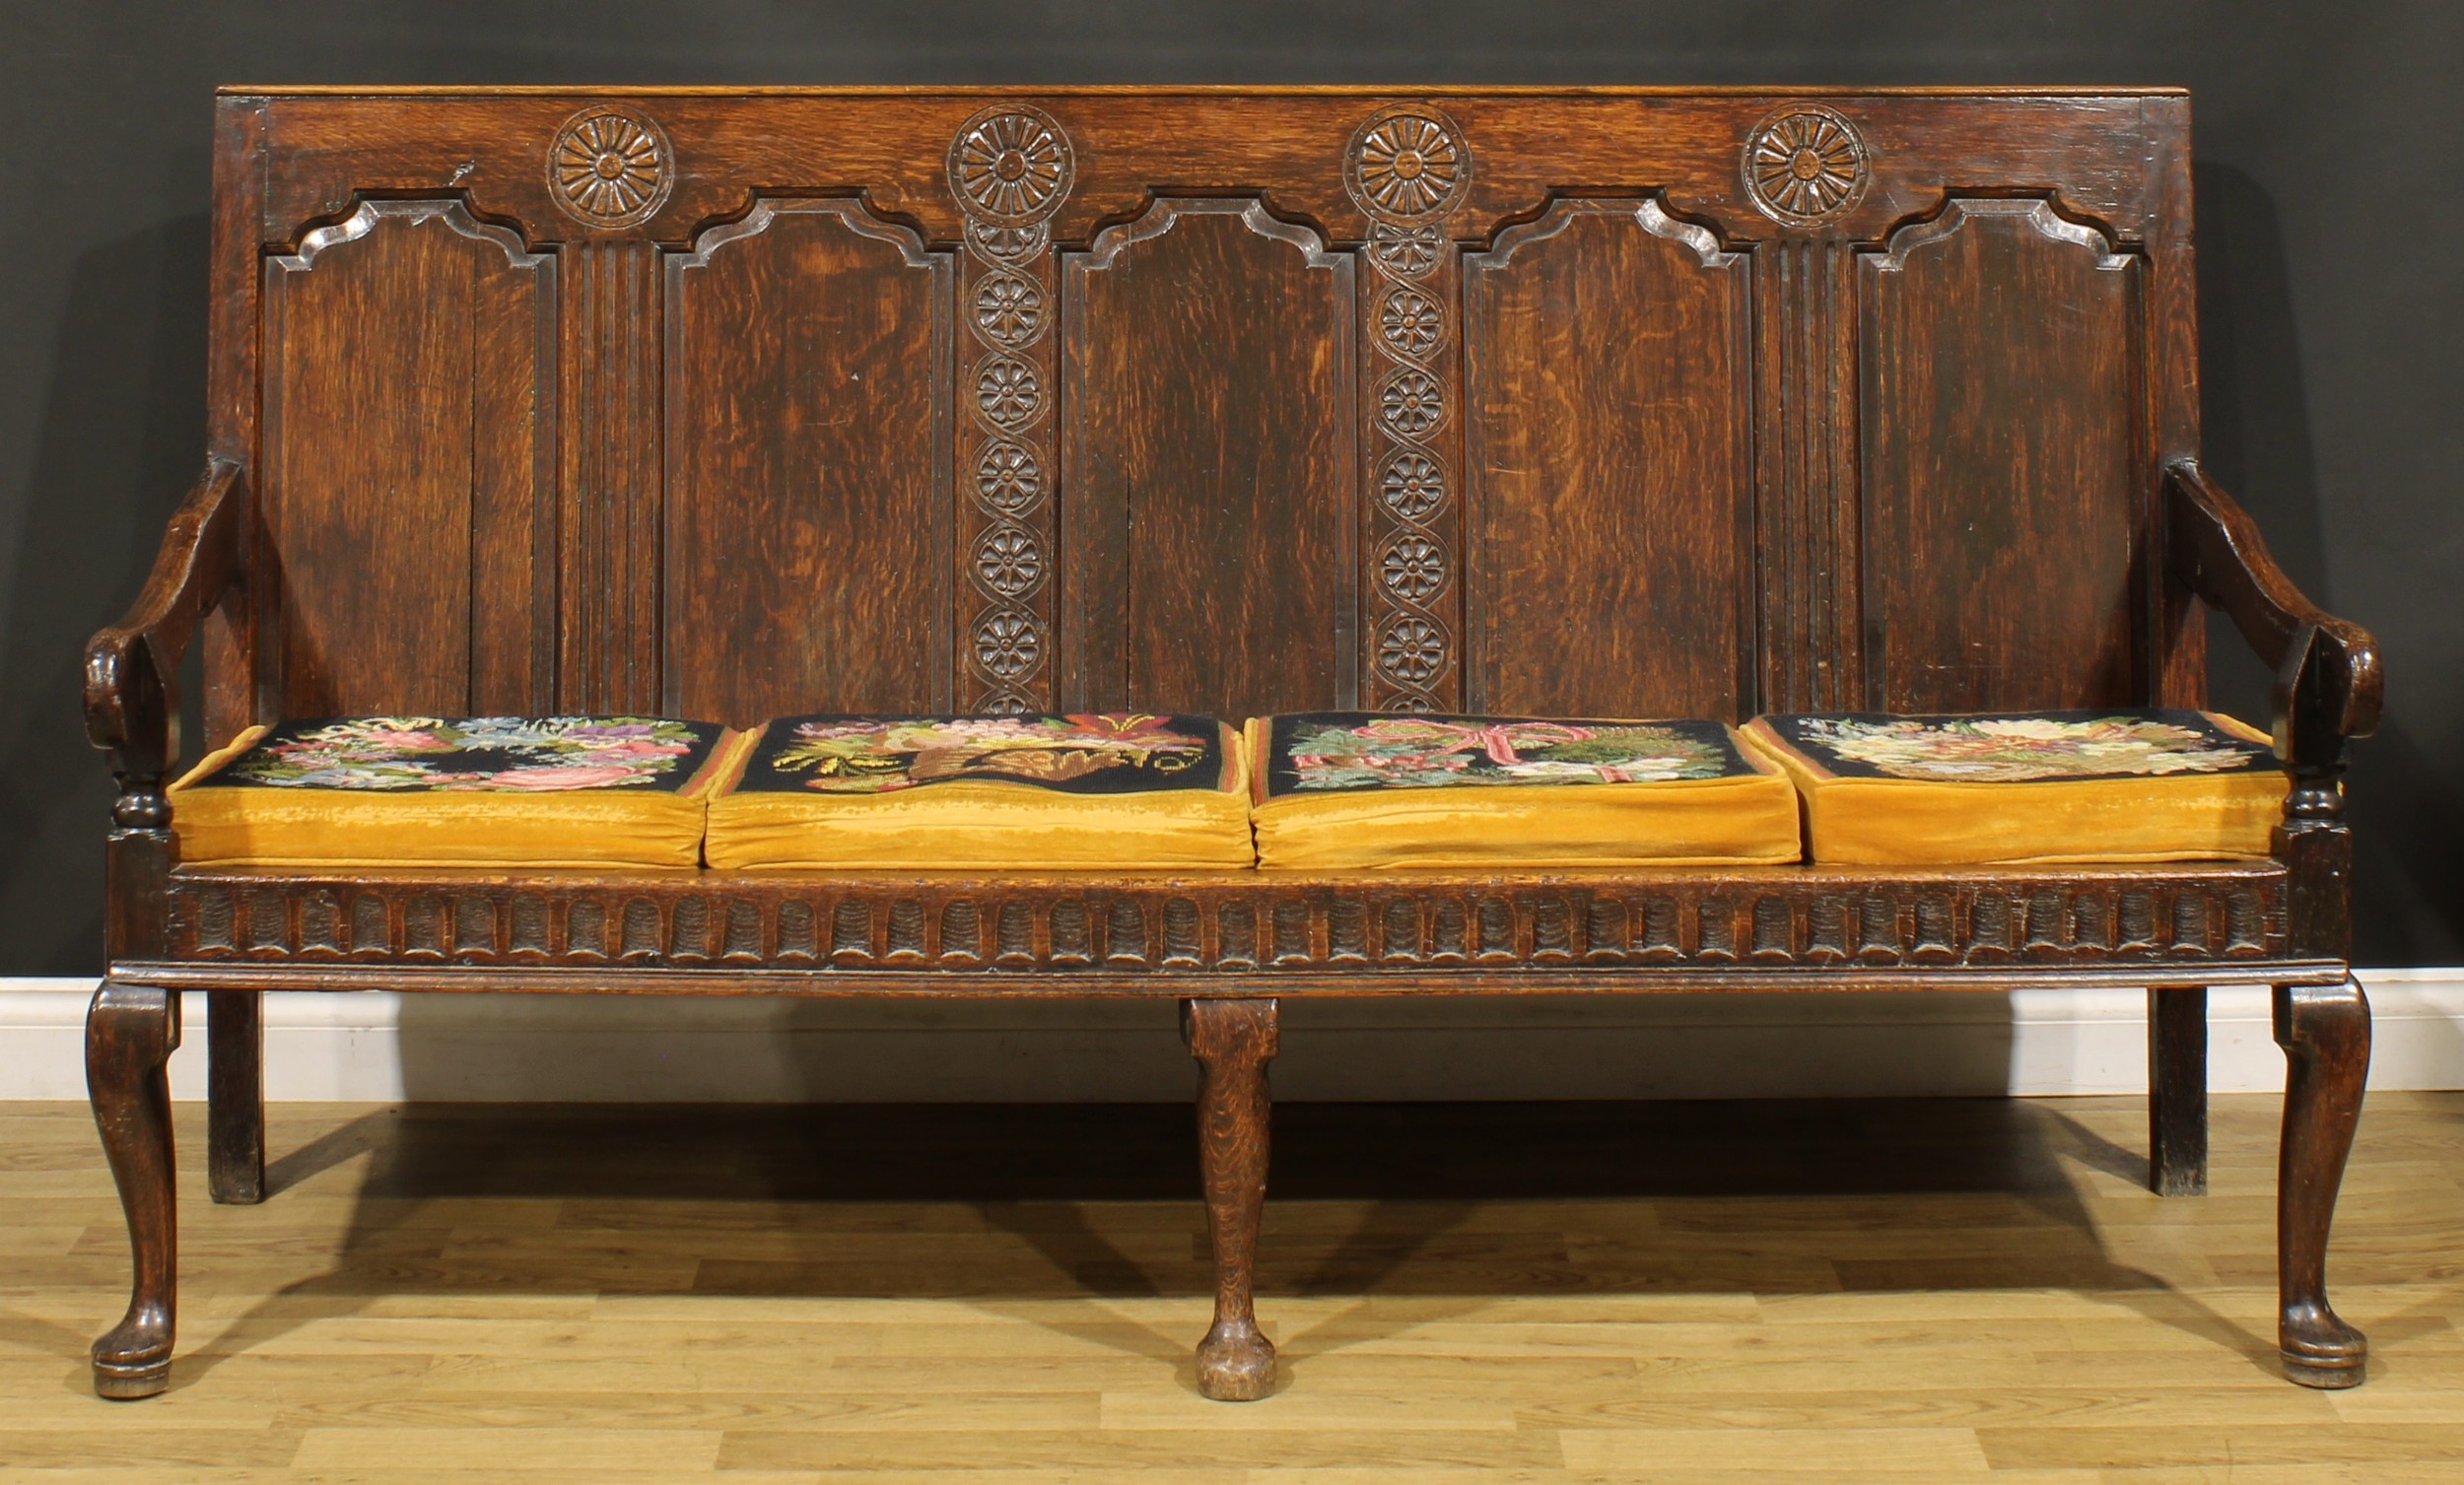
[2277,978,2370,1386]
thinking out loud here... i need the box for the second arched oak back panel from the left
[663,199,954,726]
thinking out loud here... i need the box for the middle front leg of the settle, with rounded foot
[1181,997,1276,1401]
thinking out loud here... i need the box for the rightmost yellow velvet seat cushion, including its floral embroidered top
[1745,709,2285,867]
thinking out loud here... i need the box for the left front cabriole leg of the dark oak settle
[87,985,180,1399]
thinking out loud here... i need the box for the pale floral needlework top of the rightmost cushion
[1782,711,2275,783]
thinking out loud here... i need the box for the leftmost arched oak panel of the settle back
[259,202,557,716]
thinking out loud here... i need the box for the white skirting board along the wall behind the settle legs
[0,968,2464,1104]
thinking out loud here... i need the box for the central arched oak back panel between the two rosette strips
[1062,199,1358,716]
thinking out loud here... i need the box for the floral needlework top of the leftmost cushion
[210,716,719,793]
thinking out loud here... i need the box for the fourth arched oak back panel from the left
[1464,199,1754,716]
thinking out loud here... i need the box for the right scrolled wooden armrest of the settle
[2166,460,2385,766]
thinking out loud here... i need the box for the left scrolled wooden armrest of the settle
[87,458,246,828]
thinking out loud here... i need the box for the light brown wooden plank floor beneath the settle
[0,1094,2464,1485]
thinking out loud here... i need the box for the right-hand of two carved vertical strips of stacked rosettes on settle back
[1343,103,1472,711]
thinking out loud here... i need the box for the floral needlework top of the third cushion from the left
[1269,711,1749,793]
